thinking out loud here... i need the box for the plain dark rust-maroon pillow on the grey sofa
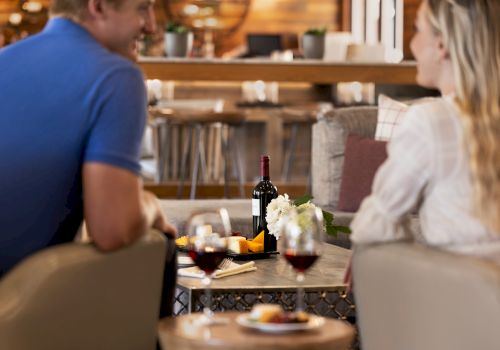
[337,134,387,212]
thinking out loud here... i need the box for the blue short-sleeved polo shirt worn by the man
[0,18,147,276]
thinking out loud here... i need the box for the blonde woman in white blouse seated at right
[347,0,500,274]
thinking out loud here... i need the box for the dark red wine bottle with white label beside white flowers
[252,156,278,252]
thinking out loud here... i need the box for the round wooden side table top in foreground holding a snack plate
[158,312,354,350]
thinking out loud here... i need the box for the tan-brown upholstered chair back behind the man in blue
[0,231,173,350]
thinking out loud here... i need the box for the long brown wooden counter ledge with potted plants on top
[139,57,416,84]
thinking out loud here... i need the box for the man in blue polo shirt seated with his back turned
[0,0,175,312]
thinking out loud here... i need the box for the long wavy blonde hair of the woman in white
[427,0,500,233]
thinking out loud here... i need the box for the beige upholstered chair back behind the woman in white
[353,243,500,350]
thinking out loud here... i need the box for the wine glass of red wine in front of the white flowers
[280,207,323,311]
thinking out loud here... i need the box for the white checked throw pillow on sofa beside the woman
[375,94,408,141]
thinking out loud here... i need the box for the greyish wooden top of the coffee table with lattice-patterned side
[177,243,351,291]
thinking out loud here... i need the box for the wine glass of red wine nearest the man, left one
[187,208,231,324]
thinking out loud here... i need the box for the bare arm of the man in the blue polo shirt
[83,162,176,251]
